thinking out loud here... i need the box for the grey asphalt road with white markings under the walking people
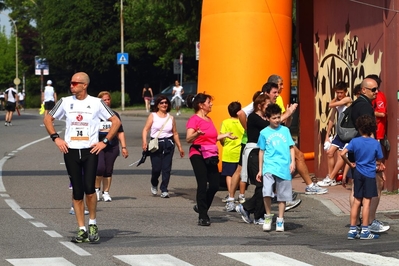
[0,110,399,266]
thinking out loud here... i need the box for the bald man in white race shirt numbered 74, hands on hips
[44,72,121,243]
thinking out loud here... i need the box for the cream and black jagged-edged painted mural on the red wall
[314,25,383,168]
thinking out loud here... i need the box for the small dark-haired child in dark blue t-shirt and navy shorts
[341,115,384,239]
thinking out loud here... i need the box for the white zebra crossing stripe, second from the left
[114,254,193,266]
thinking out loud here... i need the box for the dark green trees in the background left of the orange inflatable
[0,0,202,102]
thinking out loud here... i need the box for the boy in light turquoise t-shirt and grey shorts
[256,104,295,232]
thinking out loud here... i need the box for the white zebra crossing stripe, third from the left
[219,252,311,266]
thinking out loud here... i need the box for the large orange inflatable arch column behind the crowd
[198,0,292,163]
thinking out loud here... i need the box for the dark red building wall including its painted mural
[297,0,399,190]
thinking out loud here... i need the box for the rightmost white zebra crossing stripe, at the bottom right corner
[324,252,399,266]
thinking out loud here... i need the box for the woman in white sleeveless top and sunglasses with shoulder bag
[142,95,184,198]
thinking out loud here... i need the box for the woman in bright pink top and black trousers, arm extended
[186,93,237,226]
